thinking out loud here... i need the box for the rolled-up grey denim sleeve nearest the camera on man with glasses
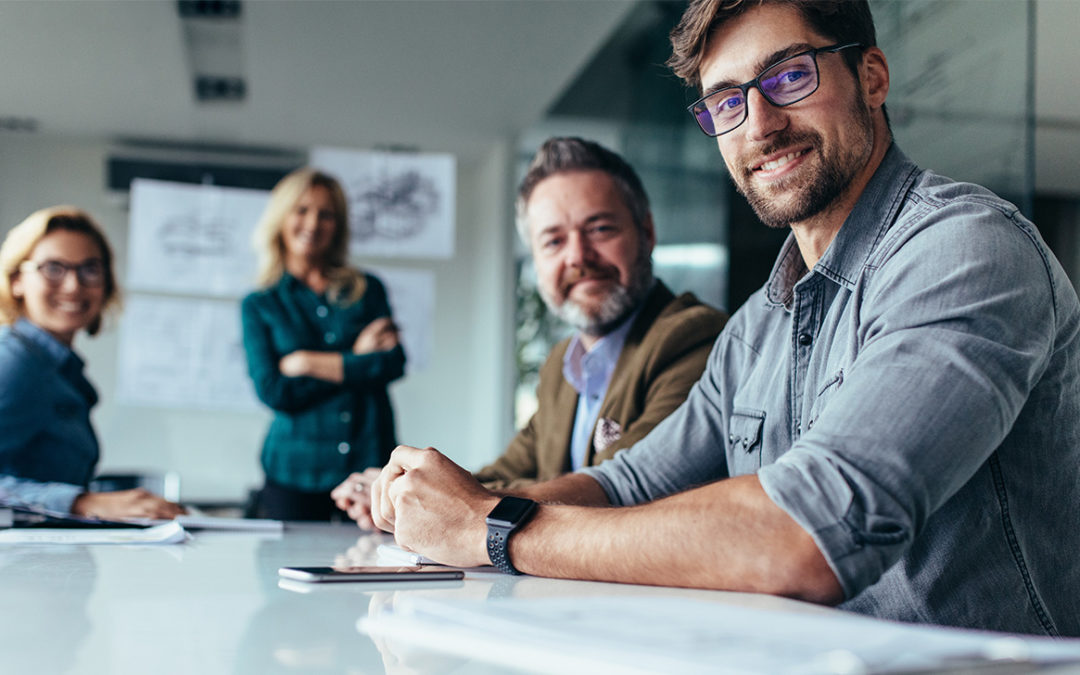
[758,205,1055,597]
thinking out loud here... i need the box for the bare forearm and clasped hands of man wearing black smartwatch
[372,446,842,604]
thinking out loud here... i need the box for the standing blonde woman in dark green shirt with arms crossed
[241,168,405,521]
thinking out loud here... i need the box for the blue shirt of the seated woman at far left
[0,319,98,512]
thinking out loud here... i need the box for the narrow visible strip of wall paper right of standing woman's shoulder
[368,266,435,373]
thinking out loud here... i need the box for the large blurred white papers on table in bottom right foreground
[357,596,1080,673]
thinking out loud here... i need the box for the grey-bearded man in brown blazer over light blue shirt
[330,138,727,520]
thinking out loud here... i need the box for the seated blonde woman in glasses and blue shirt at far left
[0,206,183,518]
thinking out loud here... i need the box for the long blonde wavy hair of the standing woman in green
[252,166,367,305]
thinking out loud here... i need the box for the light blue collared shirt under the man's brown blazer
[563,308,640,470]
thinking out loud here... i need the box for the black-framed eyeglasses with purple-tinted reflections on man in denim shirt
[687,42,863,136]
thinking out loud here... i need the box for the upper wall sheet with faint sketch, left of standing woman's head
[126,178,270,297]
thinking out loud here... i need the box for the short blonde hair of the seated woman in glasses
[0,206,120,335]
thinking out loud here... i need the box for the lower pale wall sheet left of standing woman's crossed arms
[117,295,259,411]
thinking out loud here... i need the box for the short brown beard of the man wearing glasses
[732,94,874,228]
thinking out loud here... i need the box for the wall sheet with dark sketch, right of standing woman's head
[310,148,457,258]
